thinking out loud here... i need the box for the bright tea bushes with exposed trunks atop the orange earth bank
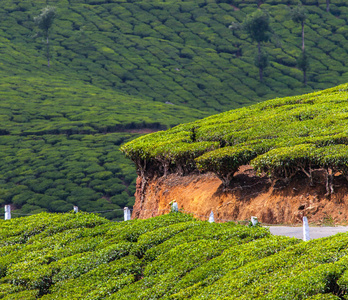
[121,84,348,192]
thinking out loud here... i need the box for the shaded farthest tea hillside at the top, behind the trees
[0,0,348,112]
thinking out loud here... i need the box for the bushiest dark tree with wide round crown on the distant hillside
[242,9,272,81]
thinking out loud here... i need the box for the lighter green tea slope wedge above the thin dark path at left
[0,75,208,136]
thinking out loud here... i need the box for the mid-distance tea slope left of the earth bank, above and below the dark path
[0,74,207,218]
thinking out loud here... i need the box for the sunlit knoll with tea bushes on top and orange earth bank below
[121,85,348,223]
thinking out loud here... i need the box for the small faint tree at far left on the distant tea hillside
[34,6,57,67]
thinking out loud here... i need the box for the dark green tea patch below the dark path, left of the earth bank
[0,133,138,219]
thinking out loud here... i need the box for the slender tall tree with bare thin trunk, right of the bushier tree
[291,4,309,84]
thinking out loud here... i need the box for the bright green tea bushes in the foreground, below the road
[0,213,348,300]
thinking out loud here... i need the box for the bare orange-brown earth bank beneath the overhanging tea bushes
[133,166,348,224]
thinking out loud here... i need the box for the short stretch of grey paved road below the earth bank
[267,226,348,239]
